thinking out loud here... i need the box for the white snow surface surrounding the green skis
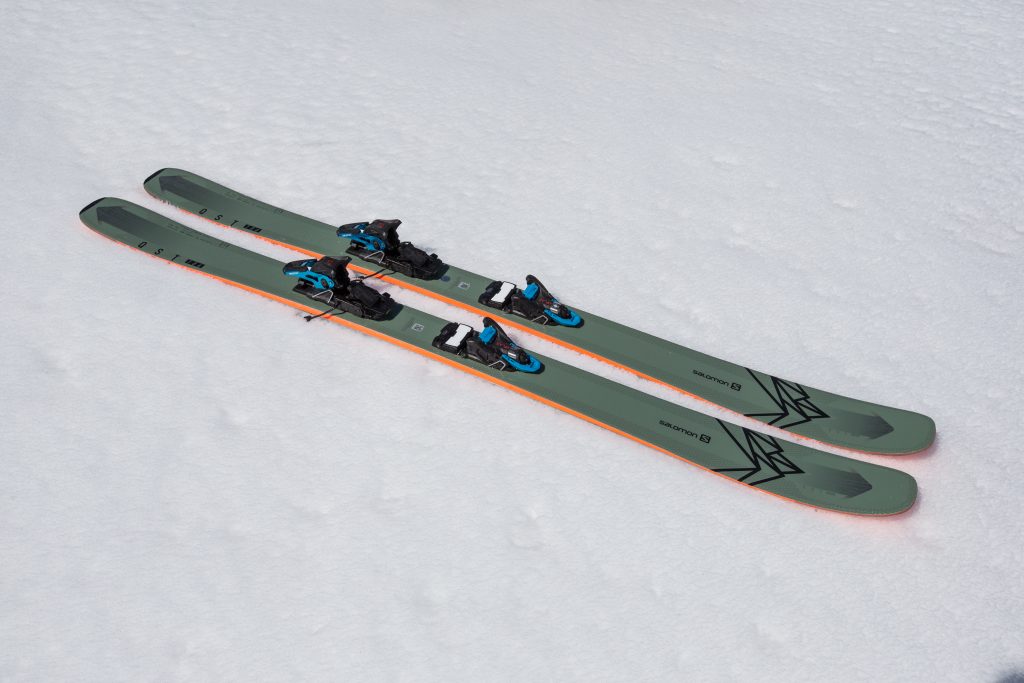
[0,0,1024,682]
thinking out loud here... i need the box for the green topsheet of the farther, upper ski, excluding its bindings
[145,168,935,455]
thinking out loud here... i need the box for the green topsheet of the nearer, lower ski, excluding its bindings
[81,198,918,515]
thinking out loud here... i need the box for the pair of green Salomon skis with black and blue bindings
[75,169,935,515]
